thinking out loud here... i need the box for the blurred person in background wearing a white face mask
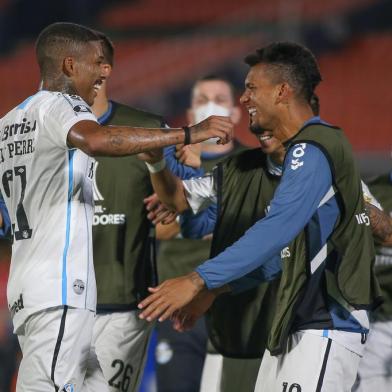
[155,75,241,392]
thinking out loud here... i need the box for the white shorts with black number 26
[83,311,152,392]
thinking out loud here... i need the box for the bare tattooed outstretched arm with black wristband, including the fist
[67,116,233,156]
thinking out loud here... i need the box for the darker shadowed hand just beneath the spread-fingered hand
[171,290,216,332]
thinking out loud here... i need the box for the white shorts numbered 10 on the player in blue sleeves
[255,332,360,392]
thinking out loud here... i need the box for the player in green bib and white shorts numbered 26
[83,32,207,392]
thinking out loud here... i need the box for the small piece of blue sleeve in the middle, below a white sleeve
[180,204,218,239]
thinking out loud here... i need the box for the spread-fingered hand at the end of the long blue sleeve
[138,272,204,321]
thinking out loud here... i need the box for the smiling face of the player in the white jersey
[72,41,105,105]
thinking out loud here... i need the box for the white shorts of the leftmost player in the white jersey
[16,307,94,392]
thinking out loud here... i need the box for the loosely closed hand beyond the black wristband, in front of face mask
[189,116,234,144]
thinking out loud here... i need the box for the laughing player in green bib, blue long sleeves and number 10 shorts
[139,42,380,392]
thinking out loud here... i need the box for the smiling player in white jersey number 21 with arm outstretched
[0,23,232,392]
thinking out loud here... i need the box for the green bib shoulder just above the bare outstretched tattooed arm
[111,101,164,127]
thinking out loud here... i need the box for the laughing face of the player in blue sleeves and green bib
[240,64,278,134]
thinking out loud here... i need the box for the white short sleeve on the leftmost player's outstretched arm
[45,93,97,149]
